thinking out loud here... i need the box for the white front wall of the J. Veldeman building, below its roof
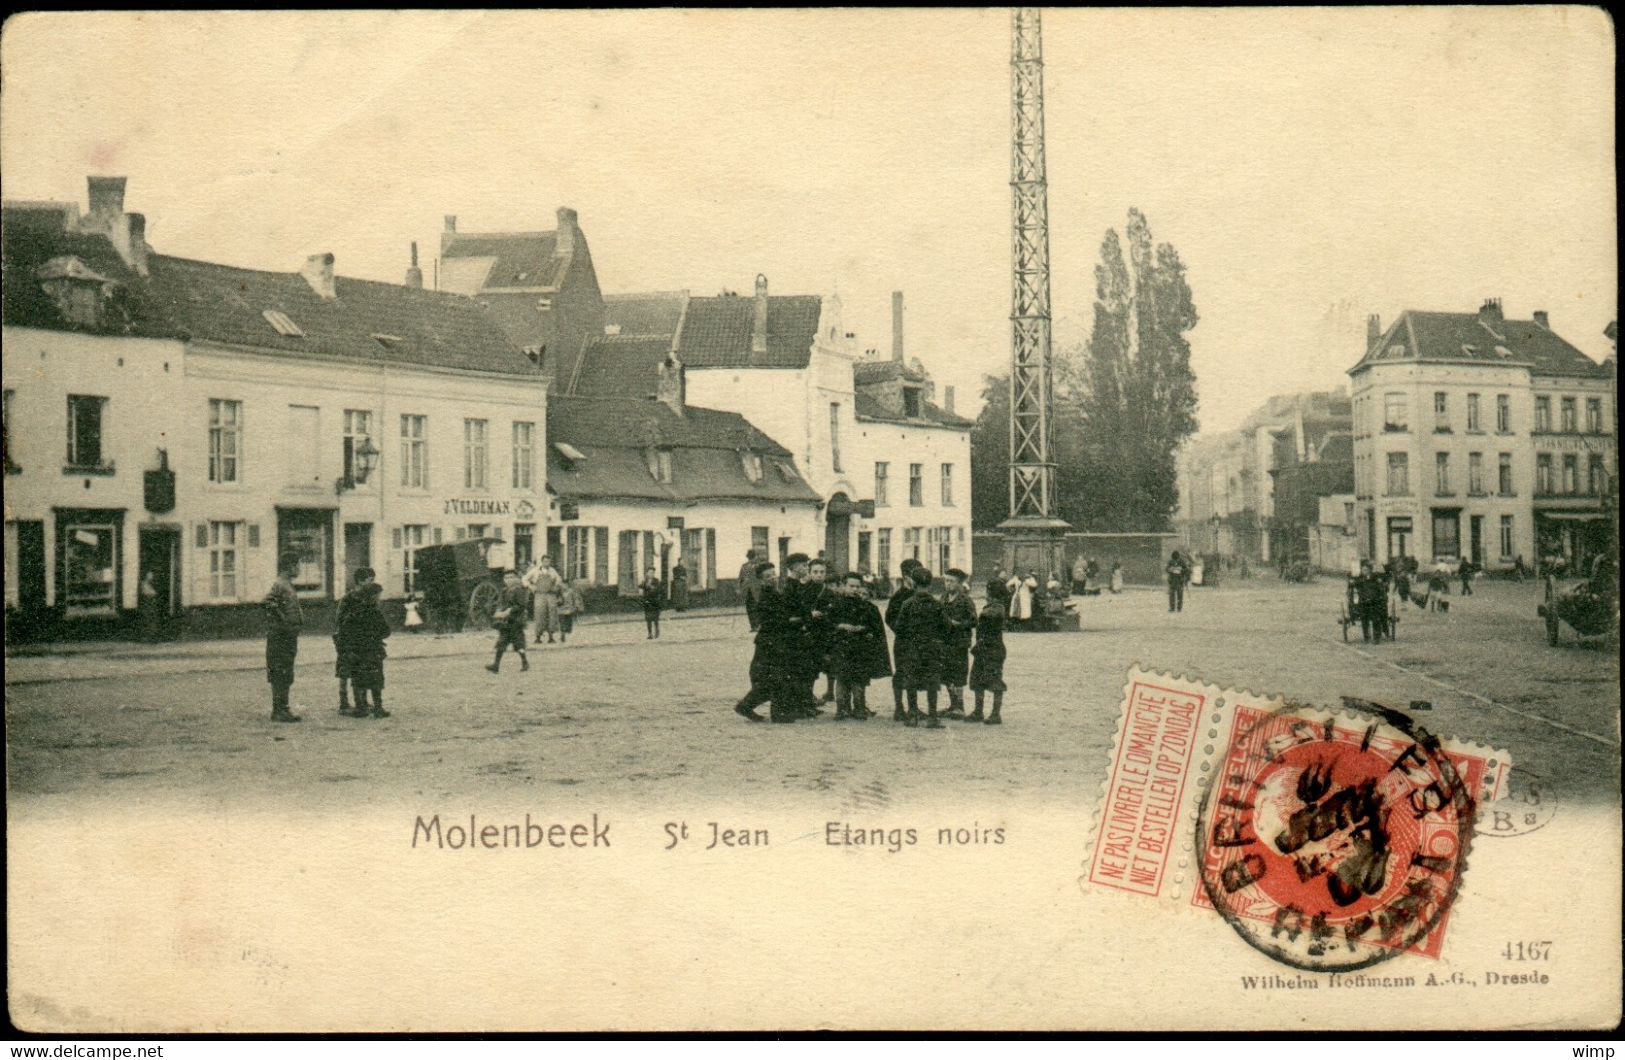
[3,318,546,618]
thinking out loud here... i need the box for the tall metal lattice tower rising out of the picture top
[1011,8,1056,520]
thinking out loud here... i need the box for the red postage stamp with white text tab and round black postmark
[1086,670,1511,971]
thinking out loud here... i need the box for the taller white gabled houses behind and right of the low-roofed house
[575,276,972,574]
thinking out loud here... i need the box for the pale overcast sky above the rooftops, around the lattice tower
[0,8,1619,431]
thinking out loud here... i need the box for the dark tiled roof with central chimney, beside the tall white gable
[678,294,822,367]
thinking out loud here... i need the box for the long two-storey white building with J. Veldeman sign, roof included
[3,179,546,631]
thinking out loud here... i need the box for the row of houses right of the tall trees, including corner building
[1180,299,1619,571]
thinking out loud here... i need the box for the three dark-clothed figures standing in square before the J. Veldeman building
[263,553,390,722]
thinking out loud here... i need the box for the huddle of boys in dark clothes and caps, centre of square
[735,553,998,728]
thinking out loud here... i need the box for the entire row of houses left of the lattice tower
[3,177,970,632]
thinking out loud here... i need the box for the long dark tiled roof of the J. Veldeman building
[5,228,536,376]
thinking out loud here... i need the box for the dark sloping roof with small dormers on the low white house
[548,397,819,504]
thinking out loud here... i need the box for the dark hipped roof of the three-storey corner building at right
[1350,309,1607,376]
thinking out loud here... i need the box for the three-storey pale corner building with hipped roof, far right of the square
[1349,299,1617,569]
